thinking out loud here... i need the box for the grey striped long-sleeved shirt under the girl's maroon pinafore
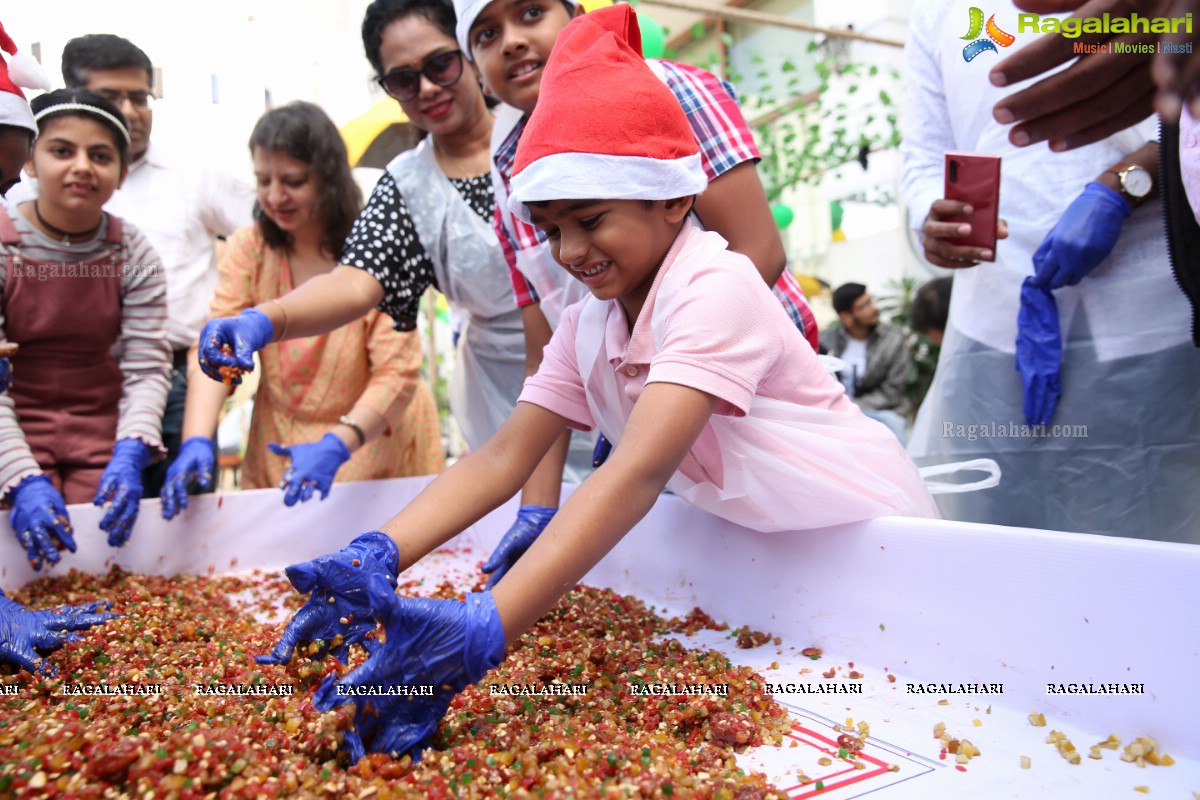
[0,203,170,499]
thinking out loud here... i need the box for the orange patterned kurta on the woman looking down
[212,227,444,488]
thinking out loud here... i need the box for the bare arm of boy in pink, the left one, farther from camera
[380,403,566,570]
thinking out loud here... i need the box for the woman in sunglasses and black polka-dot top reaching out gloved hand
[200,0,524,462]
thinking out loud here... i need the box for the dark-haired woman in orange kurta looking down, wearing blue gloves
[162,102,444,519]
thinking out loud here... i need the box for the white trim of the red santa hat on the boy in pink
[509,152,708,222]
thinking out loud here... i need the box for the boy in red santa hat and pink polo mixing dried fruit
[289,5,937,754]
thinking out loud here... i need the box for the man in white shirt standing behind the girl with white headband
[62,34,254,497]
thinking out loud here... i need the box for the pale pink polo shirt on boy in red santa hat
[518,223,860,434]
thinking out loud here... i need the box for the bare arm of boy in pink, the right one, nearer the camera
[492,384,715,644]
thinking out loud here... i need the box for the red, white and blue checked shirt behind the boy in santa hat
[492,61,818,350]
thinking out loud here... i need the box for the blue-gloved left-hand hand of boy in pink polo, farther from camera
[254,530,400,664]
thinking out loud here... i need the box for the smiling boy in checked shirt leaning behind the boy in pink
[455,0,818,594]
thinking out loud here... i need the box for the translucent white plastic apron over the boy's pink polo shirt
[575,227,938,531]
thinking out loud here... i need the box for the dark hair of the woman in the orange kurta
[250,100,362,258]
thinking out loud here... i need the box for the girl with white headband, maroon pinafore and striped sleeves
[0,89,170,569]
